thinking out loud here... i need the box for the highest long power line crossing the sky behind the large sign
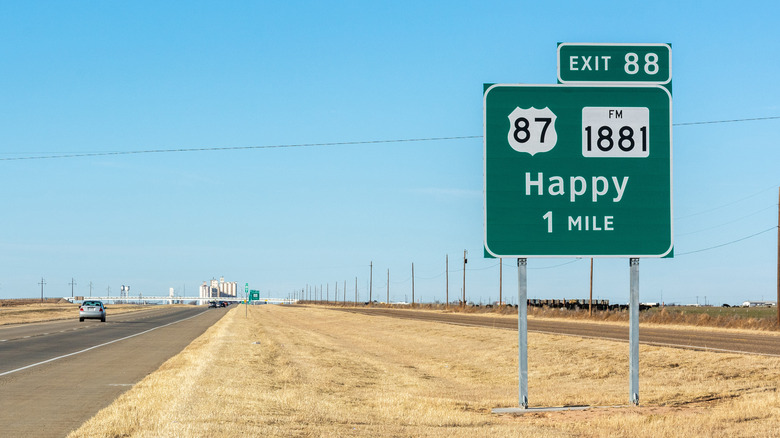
[0,116,780,161]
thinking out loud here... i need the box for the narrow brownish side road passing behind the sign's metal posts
[339,308,780,357]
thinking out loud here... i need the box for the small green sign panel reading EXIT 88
[558,43,672,85]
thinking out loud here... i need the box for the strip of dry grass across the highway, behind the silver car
[0,300,149,325]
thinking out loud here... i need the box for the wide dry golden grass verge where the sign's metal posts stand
[69,305,780,437]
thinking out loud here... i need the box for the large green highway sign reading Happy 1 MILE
[484,84,673,258]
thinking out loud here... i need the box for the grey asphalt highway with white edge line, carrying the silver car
[0,306,226,437]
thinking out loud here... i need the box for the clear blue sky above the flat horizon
[0,1,780,304]
